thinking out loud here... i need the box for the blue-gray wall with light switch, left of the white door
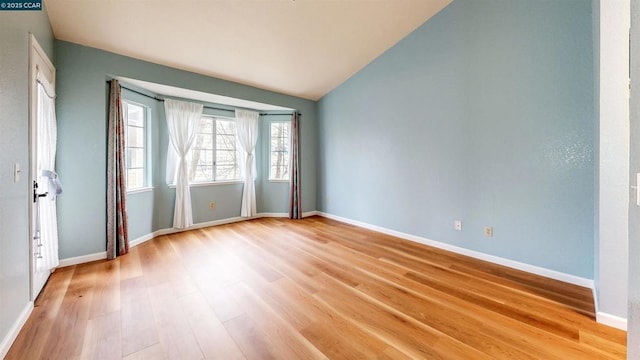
[0,4,53,351]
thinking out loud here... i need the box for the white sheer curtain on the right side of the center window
[236,109,260,217]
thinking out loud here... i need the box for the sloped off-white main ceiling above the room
[45,0,451,100]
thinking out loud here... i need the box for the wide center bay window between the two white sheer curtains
[190,116,240,182]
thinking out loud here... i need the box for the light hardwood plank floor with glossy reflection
[7,217,626,360]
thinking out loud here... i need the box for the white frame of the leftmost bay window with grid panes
[121,98,152,193]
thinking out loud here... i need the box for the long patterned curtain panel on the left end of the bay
[107,80,129,259]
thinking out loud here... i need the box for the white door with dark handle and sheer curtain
[29,35,58,301]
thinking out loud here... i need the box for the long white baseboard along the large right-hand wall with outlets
[318,212,594,289]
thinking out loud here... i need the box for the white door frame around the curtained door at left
[27,33,56,301]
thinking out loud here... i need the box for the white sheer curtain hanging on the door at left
[36,78,62,271]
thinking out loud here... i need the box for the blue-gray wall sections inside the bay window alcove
[122,83,292,240]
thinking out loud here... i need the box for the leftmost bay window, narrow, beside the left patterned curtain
[122,101,148,190]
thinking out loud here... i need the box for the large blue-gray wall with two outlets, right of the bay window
[318,0,595,279]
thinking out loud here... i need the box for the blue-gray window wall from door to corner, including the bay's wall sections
[55,41,316,259]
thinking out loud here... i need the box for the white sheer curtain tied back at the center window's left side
[164,99,202,229]
